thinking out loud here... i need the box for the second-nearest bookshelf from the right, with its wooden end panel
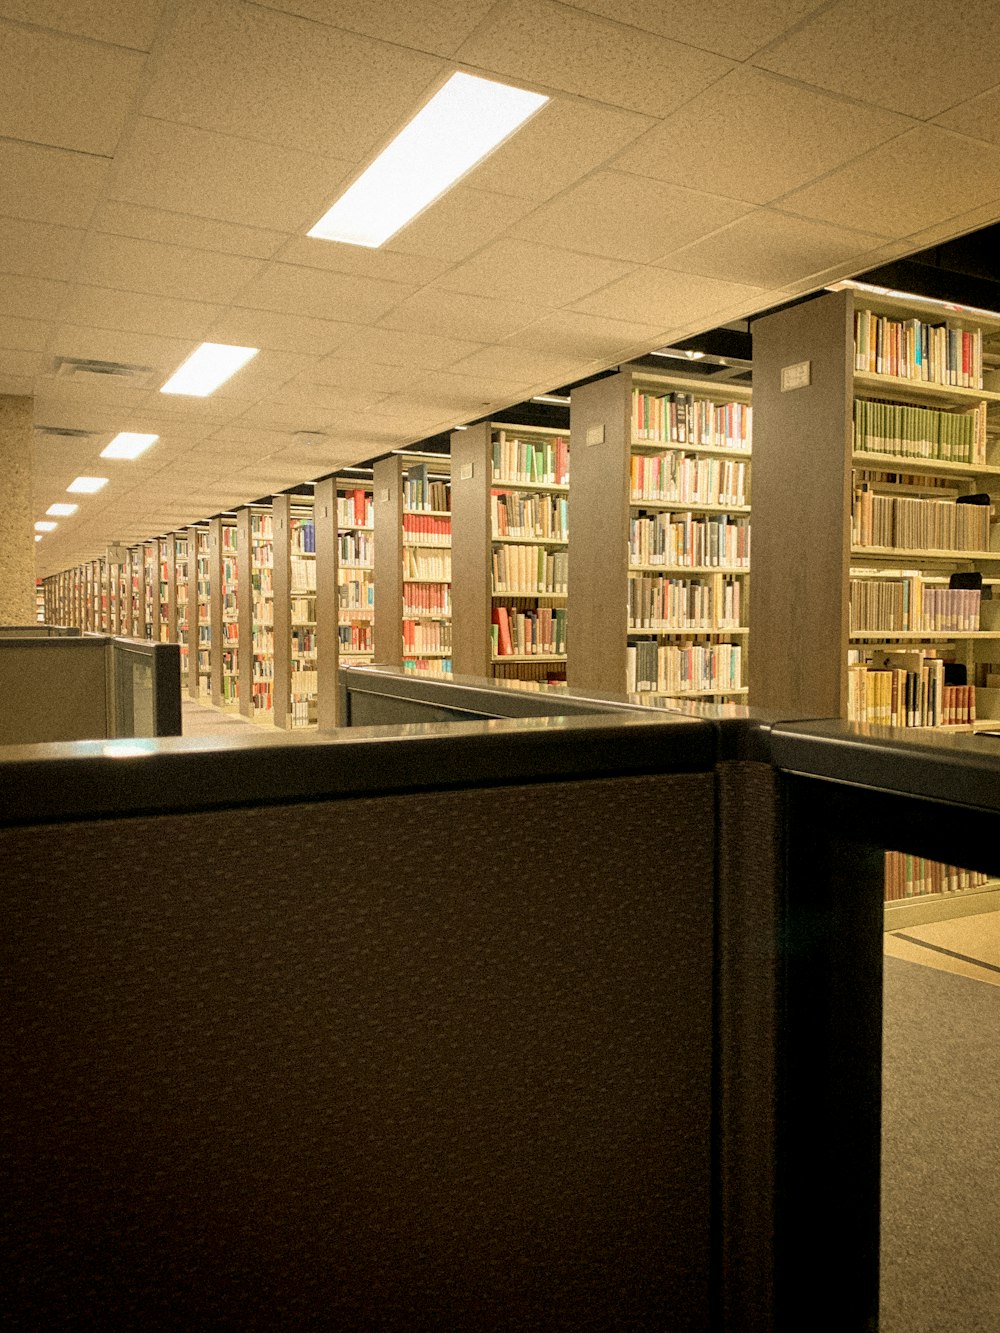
[568,367,752,702]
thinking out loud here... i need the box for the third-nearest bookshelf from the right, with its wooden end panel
[451,421,569,684]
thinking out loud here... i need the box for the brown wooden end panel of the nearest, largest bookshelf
[749,292,853,717]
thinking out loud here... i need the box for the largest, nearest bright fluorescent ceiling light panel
[309,73,548,249]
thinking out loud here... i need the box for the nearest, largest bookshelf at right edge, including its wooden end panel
[751,287,1000,730]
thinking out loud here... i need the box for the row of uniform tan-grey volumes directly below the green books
[851,483,991,551]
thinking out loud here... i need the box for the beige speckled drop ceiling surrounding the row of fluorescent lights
[0,0,1000,575]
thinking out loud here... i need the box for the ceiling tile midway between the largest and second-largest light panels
[240,264,415,324]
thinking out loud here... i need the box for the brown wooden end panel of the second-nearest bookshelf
[567,371,632,693]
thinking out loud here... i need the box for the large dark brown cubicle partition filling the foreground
[0,698,1000,1333]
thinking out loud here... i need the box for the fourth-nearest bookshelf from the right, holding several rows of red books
[373,452,452,674]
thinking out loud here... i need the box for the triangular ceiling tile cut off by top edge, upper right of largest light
[567,0,828,60]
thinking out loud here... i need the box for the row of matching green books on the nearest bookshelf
[853,399,987,463]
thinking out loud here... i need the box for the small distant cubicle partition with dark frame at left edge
[0,627,180,745]
